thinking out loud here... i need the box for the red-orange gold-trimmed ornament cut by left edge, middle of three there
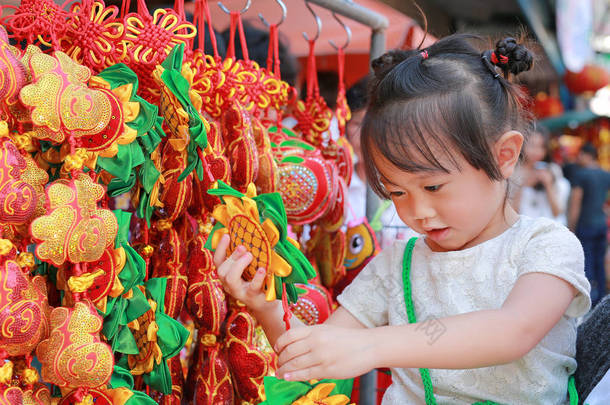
[0,133,38,225]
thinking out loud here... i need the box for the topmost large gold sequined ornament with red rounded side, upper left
[20,52,135,151]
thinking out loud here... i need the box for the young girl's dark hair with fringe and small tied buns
[361,34,533,198]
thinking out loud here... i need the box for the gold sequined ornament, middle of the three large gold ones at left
[30,173,118,266]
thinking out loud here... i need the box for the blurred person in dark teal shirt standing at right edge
[568,143,610,305]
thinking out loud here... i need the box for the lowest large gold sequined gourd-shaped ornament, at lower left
[36,301,114,389]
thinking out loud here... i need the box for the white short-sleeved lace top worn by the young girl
[338,216,591,405]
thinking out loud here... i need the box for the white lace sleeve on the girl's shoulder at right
[519,220,591,318]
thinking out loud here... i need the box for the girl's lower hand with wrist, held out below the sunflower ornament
[274,325,375,381]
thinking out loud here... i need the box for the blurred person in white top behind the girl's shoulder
[513,127,570,226]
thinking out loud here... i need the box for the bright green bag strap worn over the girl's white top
[402,237,578,405]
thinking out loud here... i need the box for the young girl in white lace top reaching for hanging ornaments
[215,35,590,405]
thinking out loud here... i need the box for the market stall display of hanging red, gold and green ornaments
[0,0,408,405]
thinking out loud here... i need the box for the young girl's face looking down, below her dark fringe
[373,147,510,251]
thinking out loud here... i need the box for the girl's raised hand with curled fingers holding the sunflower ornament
[214,235,268,311]
